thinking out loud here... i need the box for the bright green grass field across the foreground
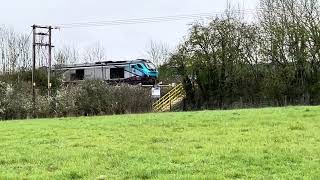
[0,107,320,179]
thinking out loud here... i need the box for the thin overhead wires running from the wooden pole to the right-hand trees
[56,9,258,28]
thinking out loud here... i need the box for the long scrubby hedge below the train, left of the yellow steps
[0,81,152,120]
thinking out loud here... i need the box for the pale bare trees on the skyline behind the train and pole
[0,26,110,75]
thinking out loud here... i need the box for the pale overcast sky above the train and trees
[0,0,258,60]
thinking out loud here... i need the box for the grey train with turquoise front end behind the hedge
[55,59,159,85]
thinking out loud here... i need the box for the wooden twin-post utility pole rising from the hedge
[32,25,59,115]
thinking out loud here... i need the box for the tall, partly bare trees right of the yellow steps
[164,0,320,109]
